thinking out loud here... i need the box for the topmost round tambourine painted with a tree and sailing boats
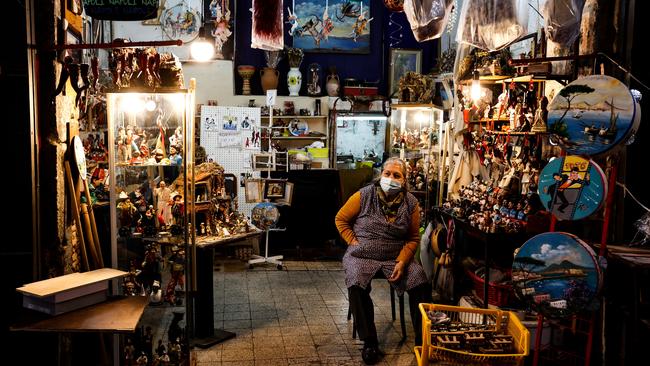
[546,75,641,155]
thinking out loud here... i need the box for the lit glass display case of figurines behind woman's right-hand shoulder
[386,104,443,214]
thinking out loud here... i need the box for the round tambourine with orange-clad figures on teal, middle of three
[537,155,607,220]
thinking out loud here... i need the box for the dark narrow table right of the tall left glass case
[192,230,264,348]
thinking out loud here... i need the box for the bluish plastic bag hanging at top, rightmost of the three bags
[542,0,585,47]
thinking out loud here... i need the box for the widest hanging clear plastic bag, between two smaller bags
[456,0,528,51]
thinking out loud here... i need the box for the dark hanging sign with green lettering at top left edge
[83,0,162,20]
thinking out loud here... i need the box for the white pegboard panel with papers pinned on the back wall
[200,105,261,217]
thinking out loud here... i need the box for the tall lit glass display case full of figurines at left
[106,87,196,360]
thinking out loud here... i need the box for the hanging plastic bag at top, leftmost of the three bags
[404,0,454,42]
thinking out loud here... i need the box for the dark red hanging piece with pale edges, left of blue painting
[251,0,284,51]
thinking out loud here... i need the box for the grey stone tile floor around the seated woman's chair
[192,261,417,366]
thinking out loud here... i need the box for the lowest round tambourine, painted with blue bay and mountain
[512,232,603,318]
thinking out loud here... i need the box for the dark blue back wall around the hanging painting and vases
[234,0,438,95]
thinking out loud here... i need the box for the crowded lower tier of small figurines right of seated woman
[439,179,544,234]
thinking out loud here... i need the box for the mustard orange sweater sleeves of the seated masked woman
[334,192,420,262]
